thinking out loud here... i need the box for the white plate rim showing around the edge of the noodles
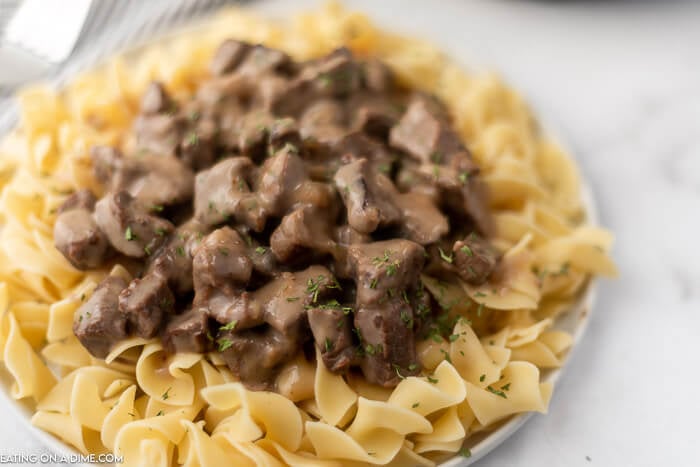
[0,4,598,467]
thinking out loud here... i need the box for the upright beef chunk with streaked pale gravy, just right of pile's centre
[334,159,401,233]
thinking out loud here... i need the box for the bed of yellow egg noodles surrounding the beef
[0,4,615,467]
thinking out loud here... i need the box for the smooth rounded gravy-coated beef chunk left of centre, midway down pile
[192,227,253,291]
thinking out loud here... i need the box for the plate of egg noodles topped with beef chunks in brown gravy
[0,4,615,466]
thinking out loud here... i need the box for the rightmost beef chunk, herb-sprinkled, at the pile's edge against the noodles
[452,234,498,285]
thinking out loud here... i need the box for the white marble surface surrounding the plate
[0,0,700,467]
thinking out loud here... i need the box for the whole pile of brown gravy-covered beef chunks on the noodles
[54,40,498,390]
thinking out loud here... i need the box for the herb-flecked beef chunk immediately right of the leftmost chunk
[95,191,173,258]
